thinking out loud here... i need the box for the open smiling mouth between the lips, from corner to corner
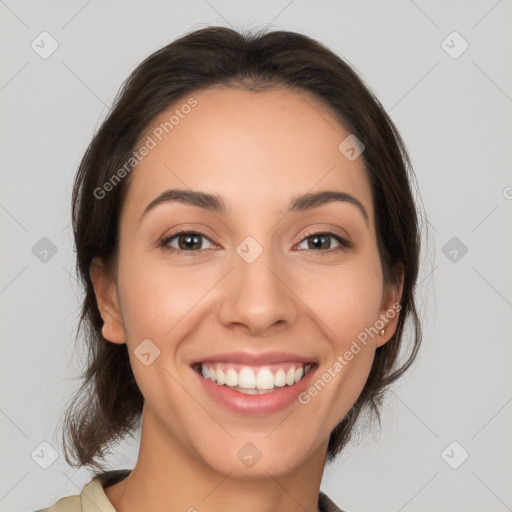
[192,361,318,395]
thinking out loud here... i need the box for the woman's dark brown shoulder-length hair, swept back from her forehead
[62,27,421,469]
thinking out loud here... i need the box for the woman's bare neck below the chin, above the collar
[105,406,327,512]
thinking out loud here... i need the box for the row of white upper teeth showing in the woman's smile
[201,363,313,395]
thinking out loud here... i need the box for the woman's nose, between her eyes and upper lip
[218,244,300,335]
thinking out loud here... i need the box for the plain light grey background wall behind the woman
[0,0,512,512]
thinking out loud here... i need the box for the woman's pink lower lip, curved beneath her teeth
[192,366,318,416]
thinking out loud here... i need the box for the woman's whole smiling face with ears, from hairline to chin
[93,89,399,478]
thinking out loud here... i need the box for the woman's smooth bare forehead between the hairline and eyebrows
[125,88,373,222]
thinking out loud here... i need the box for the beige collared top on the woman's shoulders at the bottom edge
[36,469,343,512]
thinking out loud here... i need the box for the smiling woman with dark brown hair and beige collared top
[38,27,421,512]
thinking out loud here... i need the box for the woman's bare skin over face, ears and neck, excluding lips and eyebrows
[91,88,401,512]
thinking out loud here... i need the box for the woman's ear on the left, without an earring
[89,257,126,344]
